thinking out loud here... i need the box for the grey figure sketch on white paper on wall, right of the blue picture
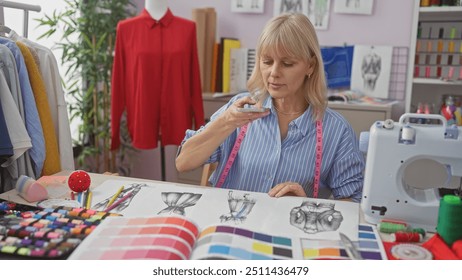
[351,45,393,99]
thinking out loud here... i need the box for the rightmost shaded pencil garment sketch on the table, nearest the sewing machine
[290,201,343,234]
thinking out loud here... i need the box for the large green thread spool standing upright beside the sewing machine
[436,195,462,246]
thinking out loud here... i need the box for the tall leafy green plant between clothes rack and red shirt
[38,0,135,175]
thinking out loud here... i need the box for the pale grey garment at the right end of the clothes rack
[8,30,75,170]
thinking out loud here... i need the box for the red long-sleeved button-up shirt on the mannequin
[111,9,204,150]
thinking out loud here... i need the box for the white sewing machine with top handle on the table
[361,114,462,232]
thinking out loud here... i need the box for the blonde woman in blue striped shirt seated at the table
[176,13,364,202]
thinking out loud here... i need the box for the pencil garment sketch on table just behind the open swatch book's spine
[157,192,202,216]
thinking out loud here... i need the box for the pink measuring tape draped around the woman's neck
[215,120,322,198]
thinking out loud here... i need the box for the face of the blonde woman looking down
[260,53,311,98]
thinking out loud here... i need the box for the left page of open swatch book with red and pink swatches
[69,216,199,260]
